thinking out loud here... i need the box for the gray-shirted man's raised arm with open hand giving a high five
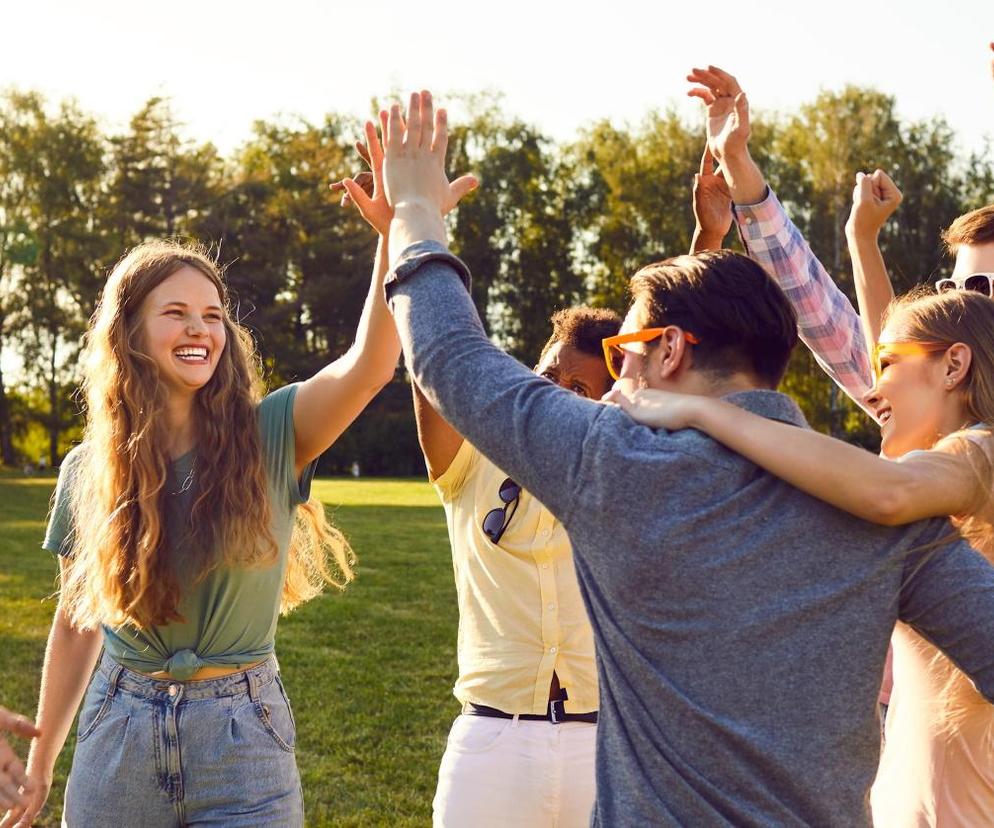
[384,93,606,518]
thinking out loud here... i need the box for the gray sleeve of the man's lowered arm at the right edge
[899,532,994,702]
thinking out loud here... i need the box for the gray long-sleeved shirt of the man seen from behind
[387,242,994,828]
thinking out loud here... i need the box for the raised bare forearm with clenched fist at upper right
[846,170,903,353]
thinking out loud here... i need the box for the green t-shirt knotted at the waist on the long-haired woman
[42,385,315,680]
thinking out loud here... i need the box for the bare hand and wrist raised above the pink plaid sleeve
[687,66,766,204]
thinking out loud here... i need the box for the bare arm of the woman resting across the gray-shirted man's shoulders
[606,389,977,526]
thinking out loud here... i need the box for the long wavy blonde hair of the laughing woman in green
[62,241,355,629]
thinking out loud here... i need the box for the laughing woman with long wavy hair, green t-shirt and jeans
[0,130,468,828]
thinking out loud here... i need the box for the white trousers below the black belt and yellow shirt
[432,715,597,828]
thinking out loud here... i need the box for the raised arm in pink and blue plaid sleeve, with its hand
[687,66,873,414]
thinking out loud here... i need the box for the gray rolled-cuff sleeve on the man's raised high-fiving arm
[386,242,606,520]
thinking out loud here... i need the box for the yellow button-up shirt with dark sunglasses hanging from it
[433,441,597,714]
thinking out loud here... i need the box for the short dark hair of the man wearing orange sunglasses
[630,250,797,388]
